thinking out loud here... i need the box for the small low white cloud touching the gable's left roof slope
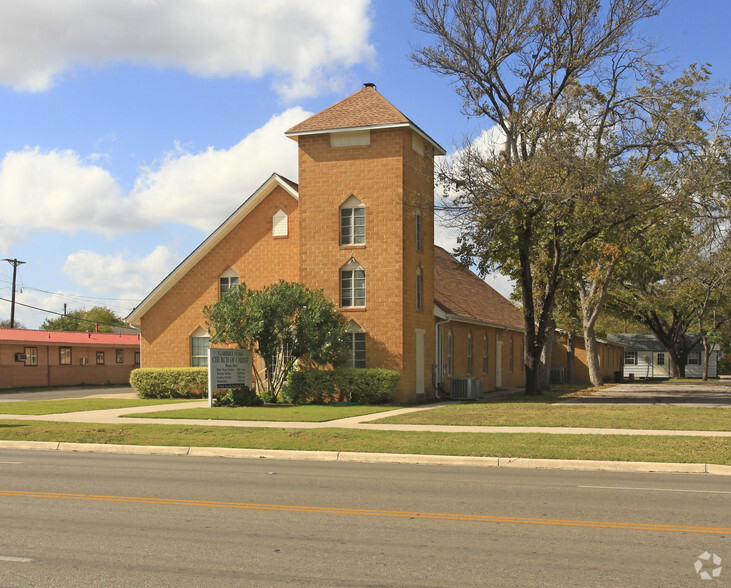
[63,245,180,306]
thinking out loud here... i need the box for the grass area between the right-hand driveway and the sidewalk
[373,402,731,431]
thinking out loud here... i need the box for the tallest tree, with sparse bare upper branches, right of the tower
[413,0,724,395]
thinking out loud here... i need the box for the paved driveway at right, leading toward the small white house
[561,380,731,408]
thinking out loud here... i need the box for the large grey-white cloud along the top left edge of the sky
[0,0,375,99]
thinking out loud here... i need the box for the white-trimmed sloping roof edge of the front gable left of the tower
[125,173,299,325]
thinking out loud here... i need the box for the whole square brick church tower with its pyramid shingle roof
[286,84,445,402]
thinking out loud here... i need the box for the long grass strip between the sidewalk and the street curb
[0,420,731,465]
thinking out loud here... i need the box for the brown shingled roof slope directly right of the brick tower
[434,245,524,331]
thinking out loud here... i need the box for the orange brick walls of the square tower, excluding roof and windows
[299,128,434,402]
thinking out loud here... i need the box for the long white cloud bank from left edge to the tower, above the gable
[0,107,310,253]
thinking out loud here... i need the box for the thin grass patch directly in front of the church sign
[125,404,399,423]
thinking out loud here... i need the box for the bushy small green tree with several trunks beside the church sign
[204,280,346,400]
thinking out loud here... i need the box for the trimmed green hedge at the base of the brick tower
[283,368,401,404]
